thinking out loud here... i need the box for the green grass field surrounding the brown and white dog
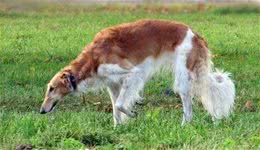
[0,3,260,149]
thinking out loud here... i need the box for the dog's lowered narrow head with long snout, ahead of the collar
[40,71,77,114]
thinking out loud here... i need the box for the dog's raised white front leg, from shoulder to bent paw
[98,64,145,122]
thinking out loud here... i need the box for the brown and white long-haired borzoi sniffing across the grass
[40,19,235,125]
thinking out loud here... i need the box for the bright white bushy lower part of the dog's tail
[201,70,235,119]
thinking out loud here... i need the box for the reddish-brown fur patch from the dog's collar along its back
[67,20,188,82]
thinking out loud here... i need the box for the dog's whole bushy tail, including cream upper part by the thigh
[193,57,235,120]
